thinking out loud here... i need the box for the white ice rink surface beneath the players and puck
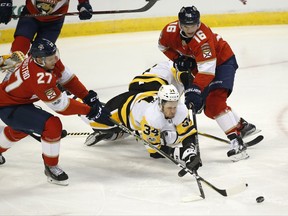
[0,25,288,216]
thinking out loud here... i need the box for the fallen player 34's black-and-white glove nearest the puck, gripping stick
[182,144,202,171]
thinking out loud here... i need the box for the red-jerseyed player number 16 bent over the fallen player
[158,6,256,161]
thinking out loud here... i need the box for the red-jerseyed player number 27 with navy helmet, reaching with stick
[0,39,113,185]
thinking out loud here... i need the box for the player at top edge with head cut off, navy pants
[0,0,93,55]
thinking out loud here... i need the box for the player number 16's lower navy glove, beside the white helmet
[185,84,204,113]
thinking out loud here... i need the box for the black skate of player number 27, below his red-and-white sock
[44,165,68,186]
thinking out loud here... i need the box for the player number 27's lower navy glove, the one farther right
[86,102,114,126]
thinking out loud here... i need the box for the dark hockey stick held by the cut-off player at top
[11,0,158,19]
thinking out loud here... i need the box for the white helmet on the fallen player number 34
[158,84,180,105]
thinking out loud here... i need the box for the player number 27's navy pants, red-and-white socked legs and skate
[0,104,68,185]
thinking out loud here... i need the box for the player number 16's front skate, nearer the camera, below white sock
[227,134,249,162]
